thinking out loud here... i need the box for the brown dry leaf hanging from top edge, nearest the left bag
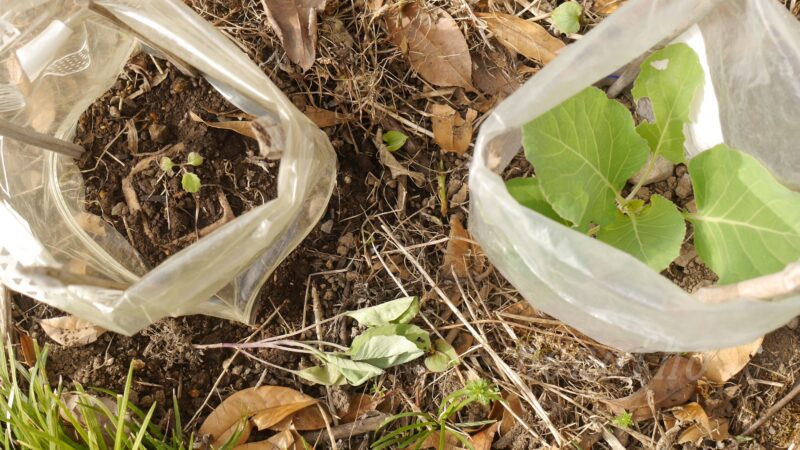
[261,0,325,70]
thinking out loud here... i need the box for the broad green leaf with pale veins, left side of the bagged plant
[522,87,649,230]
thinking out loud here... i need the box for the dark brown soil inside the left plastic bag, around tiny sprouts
[76,54,278,267]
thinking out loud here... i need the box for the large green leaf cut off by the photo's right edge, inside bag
[688,144,800,284]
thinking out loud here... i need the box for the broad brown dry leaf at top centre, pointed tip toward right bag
[386,3,474,90]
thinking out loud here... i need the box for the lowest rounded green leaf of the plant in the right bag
[597,195,686,272]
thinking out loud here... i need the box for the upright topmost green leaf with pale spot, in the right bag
[631,44,703,164]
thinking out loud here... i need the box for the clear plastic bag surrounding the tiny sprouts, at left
[0,0,336,334]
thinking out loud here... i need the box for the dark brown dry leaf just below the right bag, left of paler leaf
[609,356,703,422]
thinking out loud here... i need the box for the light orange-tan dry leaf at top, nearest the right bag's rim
[477,13,564,64]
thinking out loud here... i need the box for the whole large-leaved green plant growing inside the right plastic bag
[507,44,800,284]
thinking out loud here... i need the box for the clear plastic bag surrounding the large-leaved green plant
[469,0,800,352]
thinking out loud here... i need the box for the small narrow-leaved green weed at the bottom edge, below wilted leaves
[371,380,503,450]
